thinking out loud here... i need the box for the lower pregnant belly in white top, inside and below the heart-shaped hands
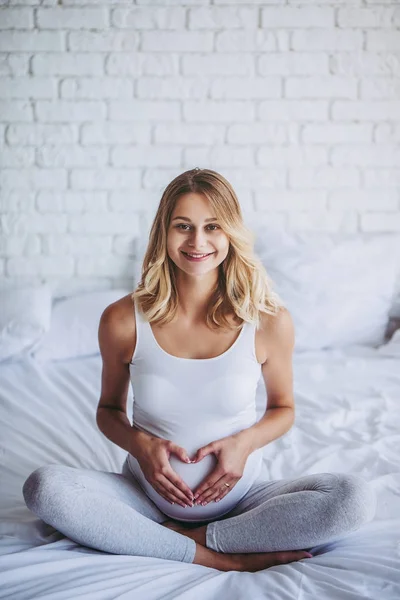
[128,448,262,521]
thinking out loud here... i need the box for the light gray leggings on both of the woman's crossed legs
[23,462,376,563]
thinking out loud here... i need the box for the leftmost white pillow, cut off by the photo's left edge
[0,285,52,361]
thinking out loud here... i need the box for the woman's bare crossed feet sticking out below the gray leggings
[162,520,311,573]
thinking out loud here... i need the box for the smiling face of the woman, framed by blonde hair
[167,193,229,276]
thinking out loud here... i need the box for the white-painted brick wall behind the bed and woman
[0,0,400,293]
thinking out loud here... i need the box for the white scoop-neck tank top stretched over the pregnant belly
[127,301,262,521]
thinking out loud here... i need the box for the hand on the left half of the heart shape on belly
[134,432,193,506]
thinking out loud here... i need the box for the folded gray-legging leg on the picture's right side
[193,473,376,553]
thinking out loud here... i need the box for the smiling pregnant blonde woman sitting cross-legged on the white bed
[23,169,376,571]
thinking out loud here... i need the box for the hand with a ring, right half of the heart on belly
[192,434,250,504]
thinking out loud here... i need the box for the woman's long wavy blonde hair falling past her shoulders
[131,167,283,330]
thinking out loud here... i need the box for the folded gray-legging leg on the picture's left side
[23,465,196,563]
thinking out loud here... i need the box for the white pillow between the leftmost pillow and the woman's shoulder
[33,289,133,362]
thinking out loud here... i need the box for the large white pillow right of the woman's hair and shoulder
[253,227,400,351]
